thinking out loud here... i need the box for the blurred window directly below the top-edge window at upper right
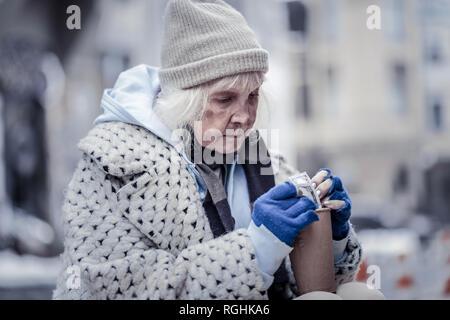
[388,63,408,115]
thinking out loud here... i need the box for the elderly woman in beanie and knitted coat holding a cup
[54,0,380,299]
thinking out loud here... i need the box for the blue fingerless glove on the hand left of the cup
[252,182,319,247]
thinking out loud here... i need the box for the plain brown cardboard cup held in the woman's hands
[290,208,336,294]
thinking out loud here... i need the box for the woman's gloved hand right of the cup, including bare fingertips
[311,168,352,240]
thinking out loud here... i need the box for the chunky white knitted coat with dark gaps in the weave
[53,122,361,299]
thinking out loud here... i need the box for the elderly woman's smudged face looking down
[194,87,259,154]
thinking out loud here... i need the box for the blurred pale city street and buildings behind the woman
[0,0,450,299]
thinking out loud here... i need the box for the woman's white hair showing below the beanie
[154,72,269,136]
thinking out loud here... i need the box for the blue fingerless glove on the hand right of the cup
[319,168,352,240]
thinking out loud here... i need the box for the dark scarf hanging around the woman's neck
[189,130,288,299]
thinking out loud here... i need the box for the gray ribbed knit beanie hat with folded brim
[159,0,269,89]
